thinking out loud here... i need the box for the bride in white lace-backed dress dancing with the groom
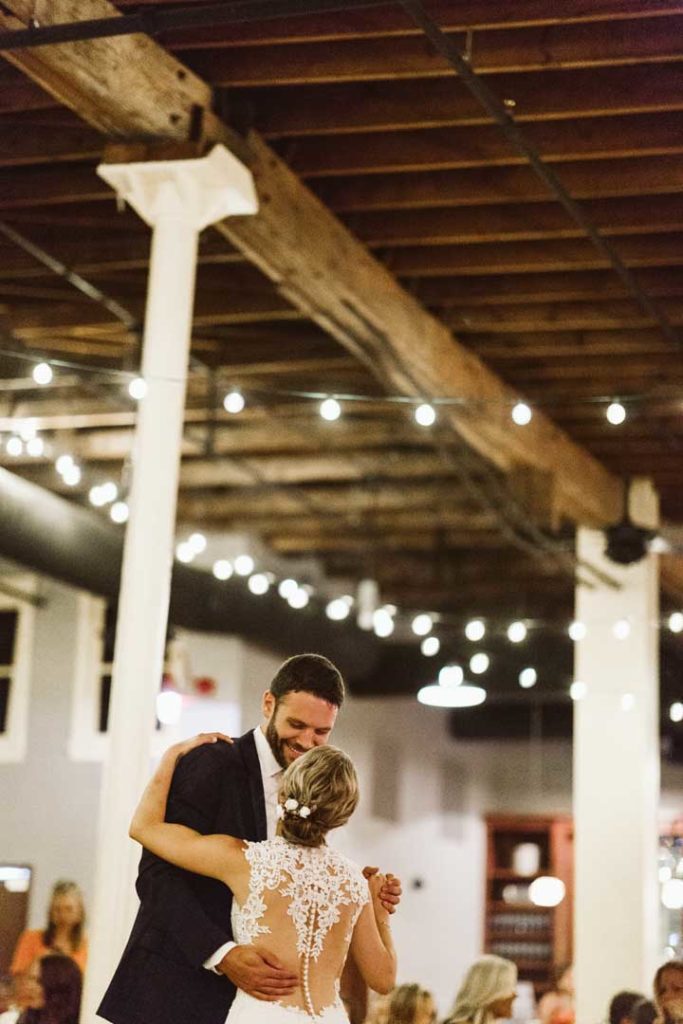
[130,733,396,1024]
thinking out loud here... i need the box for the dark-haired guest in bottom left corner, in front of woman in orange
[0,953,82,1024]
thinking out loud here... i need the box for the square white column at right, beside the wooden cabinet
[573,480,659,1024]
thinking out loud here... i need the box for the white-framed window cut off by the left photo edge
[0,577,35,763]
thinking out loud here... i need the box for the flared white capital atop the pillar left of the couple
[97,144,258,231]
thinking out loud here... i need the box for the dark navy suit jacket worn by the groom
[97,732,267,1024]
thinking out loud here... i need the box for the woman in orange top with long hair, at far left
[9,882,88,974]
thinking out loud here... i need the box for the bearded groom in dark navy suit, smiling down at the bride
[97,654,400,1024]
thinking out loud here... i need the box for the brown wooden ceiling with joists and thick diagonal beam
[0,0,683,741]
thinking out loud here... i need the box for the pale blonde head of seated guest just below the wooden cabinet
[447,954,517,1024]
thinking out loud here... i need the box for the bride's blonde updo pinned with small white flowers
[278,744,358,846]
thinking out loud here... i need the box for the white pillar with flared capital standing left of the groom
[81,146,257,1024]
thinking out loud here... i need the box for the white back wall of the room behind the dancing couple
[0,584,683,1013]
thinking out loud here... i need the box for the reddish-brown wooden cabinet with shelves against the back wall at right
[484,815,573,995]
